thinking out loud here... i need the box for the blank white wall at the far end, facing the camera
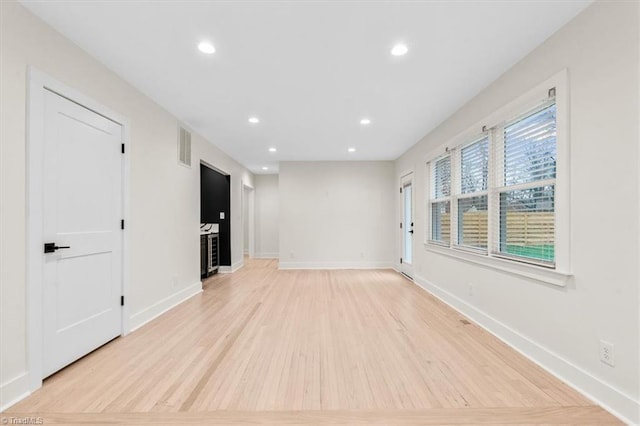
[279,161,396,268]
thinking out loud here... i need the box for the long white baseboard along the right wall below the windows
[414,276,640,424]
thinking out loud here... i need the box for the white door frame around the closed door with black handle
[25,66,131,392]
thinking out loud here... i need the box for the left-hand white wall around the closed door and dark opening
[0,1,253,406]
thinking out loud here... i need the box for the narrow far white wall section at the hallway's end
[254,175,280,258]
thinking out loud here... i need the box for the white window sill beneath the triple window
[424,243,573,287]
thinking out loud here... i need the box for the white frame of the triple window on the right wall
[424,70,571,286]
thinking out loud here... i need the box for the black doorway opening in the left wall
[200,164,231,266]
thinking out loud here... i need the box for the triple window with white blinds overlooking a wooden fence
[427,74,569,274]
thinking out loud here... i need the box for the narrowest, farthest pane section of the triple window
[430,155,451,245]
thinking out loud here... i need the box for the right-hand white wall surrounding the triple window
[395,2,640,422]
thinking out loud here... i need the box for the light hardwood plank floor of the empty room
[3,260,620,425]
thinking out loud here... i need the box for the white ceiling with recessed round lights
[22,0,590,173]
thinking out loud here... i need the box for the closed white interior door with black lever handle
[42,90,123,377]
